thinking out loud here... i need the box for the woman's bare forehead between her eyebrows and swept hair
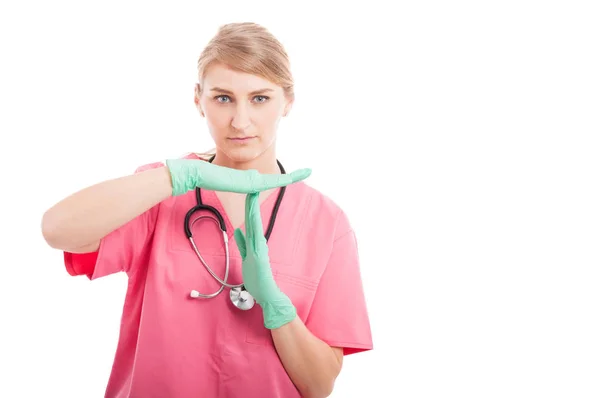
[199,64,280,94]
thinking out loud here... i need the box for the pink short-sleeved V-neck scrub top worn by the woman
[64,155,373,398]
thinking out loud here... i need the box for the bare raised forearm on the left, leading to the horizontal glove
[42,167,172,250]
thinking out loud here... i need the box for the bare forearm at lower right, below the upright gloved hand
[271,317,342,398]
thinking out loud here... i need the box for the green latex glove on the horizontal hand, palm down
[166,159,311,196]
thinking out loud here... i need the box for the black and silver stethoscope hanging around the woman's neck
[184,155,286,310]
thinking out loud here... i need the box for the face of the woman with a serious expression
[194,64,292,163]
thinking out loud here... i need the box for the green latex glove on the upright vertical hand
[234,193,296,329]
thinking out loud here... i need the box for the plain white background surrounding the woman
[0,1,600,398]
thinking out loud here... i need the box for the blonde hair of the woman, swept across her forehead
[194,22,294,160]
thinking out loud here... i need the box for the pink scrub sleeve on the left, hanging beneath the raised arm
[64,162,163,280]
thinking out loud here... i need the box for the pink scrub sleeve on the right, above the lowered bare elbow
[306,212,373,355]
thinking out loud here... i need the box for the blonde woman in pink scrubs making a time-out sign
[42,23,372,398]
